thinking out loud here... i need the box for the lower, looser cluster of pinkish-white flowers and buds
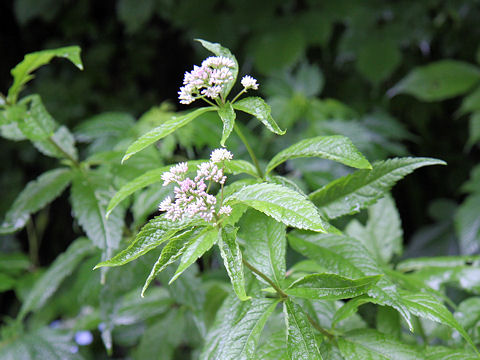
[159,149,233,222]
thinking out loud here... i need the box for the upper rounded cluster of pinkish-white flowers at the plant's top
[178,56,235,104]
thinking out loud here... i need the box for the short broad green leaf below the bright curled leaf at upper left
[18,95,57,141]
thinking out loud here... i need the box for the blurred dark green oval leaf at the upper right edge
[389,60,480,101]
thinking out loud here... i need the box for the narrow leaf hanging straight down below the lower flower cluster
[218,225,250,301]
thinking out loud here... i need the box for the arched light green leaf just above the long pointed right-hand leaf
[266,135,372,174]
